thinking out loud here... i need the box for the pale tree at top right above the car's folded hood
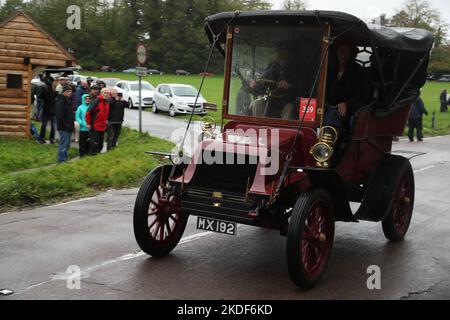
[389,0,447,47]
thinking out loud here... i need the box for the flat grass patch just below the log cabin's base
[0,138,77,175]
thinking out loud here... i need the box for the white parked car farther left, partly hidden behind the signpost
[115,81,155,108]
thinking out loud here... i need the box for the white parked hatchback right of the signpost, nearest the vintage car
[153,84,207,117]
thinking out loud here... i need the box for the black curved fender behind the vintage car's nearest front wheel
[303,168,358,222]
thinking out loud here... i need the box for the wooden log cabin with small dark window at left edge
[0,11,76,137]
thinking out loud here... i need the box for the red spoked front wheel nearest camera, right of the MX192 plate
[287,189,335,289]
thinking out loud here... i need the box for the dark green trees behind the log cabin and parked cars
[0,0,250,73]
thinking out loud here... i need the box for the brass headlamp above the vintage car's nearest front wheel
[310,127,338,168]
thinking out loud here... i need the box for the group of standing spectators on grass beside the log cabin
[32,73,128,163]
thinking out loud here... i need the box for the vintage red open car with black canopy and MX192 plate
[134,11,434,289]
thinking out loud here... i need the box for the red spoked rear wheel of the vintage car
[383,161,415,242]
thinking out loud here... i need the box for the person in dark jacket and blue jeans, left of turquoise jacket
[55,85,75,163]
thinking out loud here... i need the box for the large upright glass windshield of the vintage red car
[228,26,323,122]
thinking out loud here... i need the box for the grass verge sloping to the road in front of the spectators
[0,128,173,212]
